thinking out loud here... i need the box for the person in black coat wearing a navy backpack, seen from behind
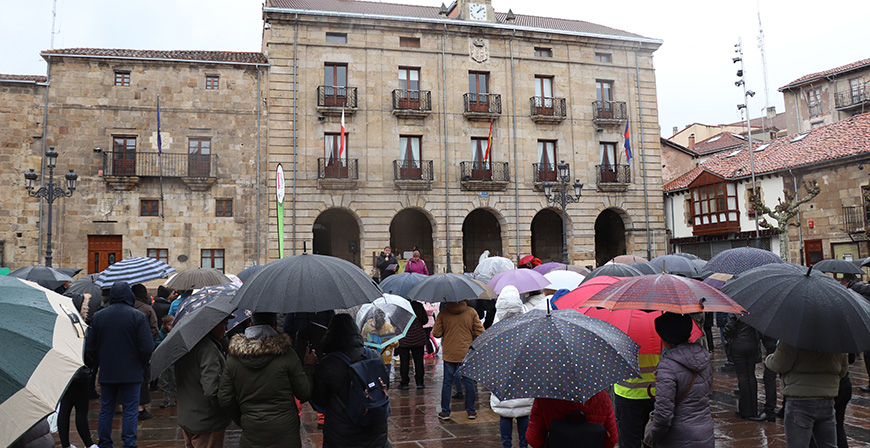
[311,314,389,448]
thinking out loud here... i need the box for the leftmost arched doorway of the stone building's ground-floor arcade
[311,208,360,266]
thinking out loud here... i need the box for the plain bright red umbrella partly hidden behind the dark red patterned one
[554,275,704,354]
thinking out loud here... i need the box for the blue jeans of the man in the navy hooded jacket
[97,383,142,448]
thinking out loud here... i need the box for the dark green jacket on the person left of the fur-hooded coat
[175,333,230,434]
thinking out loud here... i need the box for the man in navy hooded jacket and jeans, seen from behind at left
[85,282,154,447]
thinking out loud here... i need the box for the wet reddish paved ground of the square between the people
[55,330,870,448]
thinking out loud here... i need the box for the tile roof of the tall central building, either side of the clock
[266,0,648,39]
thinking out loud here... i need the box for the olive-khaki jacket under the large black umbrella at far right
[764,344,849,400]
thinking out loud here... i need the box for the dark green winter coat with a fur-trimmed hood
[220,325,314,448]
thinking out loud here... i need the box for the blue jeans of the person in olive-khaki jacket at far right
[785,398,837,448]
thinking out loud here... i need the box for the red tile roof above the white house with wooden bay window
[664,113,870,192]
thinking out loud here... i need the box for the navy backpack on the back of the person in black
[335,348,390,426]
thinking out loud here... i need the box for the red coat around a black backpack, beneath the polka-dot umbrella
[526,391,619,448]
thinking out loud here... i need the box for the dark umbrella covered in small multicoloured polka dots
[459,310,640,403]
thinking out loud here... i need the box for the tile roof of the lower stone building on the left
[41,48,269,64]
